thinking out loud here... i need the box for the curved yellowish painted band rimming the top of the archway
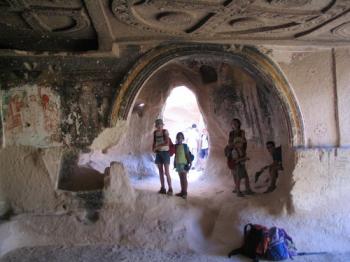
[110,44,305,147]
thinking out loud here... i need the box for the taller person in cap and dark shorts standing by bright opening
[152,119,173,195]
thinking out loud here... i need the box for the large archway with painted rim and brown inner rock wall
[110,44,304,201]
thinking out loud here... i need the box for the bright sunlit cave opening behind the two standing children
[130,85,209,192]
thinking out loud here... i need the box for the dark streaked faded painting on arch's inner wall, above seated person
[212,64,283,146]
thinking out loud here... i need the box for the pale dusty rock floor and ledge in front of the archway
[0,168,350,262]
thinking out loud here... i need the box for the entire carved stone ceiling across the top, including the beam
[0,0,350,51]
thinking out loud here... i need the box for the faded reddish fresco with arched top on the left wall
[2,85,61,147]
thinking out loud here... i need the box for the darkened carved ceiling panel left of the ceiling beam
[0,0,98,51]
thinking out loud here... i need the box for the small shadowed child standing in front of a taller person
[232,137,254,197]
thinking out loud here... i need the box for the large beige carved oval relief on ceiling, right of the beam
[111,0,349,38]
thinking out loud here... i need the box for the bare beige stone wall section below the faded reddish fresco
[0,146,65,213]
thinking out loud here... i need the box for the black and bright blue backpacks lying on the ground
[228,224,298,261]
